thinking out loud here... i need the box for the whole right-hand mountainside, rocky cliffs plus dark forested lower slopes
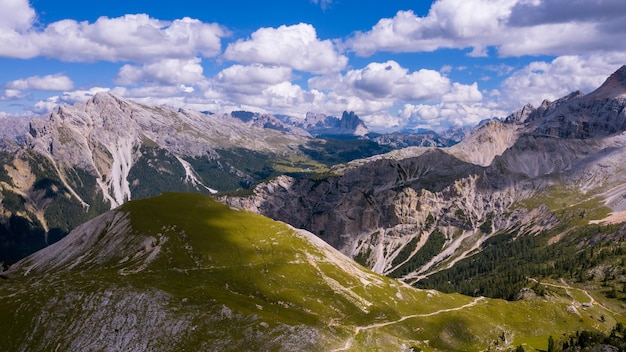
[222,66,626,302]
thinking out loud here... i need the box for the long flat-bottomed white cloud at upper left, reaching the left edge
[0,8,229,63]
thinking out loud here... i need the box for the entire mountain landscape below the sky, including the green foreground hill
[0,66,626,351]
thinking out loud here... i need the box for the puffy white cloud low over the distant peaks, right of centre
[309,60,492,130]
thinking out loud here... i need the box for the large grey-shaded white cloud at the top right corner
[346,0,626,57]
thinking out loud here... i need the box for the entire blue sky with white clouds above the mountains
[0,0,626,131]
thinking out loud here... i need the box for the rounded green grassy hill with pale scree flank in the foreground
[0,193,616,351]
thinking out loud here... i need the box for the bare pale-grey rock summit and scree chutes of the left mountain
[27,93,310,208]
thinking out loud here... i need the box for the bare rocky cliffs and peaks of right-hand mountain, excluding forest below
[226,67,626,282]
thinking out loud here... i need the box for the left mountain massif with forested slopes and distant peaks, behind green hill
[0,93,436,264]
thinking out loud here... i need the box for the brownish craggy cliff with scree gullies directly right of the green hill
[225,149,533,278]
